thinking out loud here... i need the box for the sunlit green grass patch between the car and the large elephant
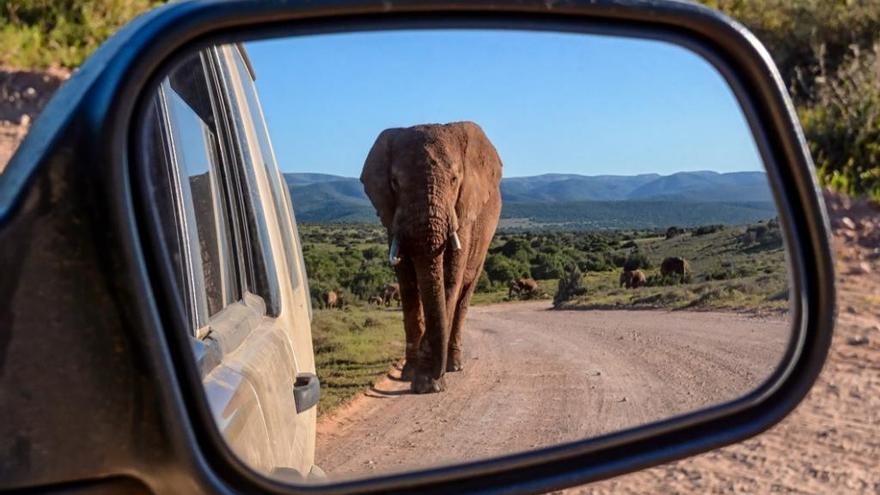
[312,306,404,415]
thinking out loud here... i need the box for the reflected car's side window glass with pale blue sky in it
[163,55,241,327]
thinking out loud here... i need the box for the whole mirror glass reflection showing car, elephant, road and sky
[144,30,791,482]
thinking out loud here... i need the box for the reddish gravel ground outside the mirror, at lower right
[580,193,880,495]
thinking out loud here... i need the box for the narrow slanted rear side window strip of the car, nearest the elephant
[230,49,301,294]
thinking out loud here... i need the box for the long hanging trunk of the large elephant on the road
[413,252,449,380]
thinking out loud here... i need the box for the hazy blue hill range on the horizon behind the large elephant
[284,171,776,229]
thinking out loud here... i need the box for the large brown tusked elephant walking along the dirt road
[361,122,501,393]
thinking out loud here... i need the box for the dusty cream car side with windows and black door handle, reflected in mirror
[144,46,319,476]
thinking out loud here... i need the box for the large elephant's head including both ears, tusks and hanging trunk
[361,122,501,390]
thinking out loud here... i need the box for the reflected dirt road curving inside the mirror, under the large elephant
[317,302,789,476]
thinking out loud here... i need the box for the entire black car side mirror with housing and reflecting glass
[0,0,834,493]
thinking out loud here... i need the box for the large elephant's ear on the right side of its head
[455,122,501,222]
